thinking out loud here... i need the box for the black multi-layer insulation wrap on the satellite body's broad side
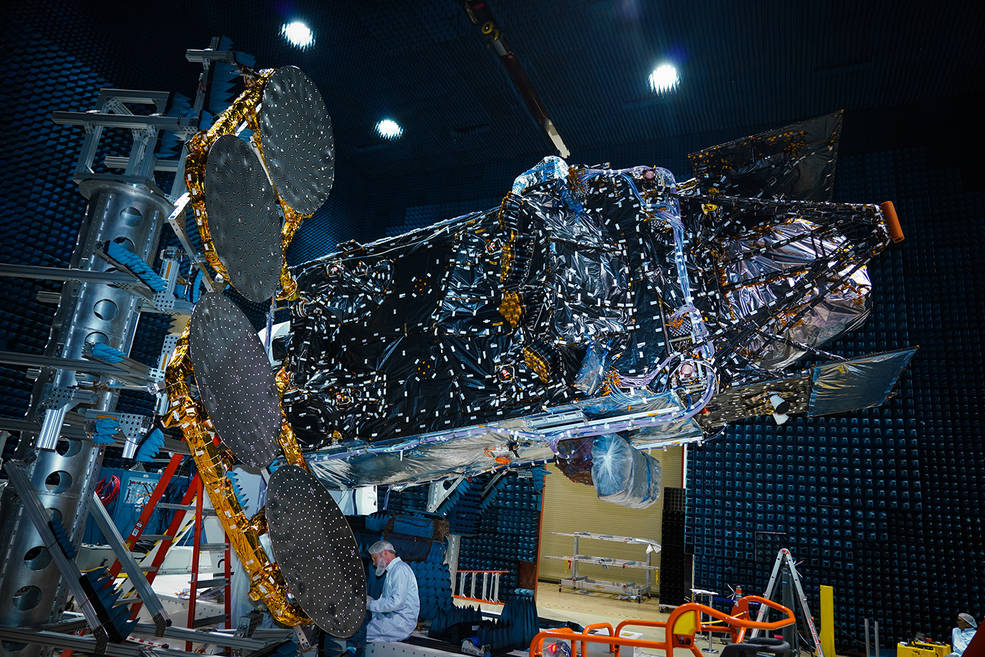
[284,158,686,444]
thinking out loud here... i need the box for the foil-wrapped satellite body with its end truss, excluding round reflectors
[283,113,910,485]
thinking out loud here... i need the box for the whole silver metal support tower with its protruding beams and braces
[0,37,258,657]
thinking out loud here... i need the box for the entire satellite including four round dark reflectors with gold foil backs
[166,67,913,636]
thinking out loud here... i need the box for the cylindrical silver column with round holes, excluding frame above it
[0,179,171,657]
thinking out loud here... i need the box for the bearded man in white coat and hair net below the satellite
[366,541,421,643]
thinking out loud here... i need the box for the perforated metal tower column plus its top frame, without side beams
[0,89,181,657]
